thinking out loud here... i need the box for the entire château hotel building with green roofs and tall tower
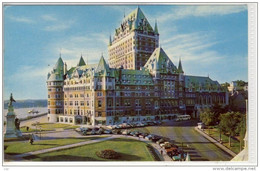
[47,7,228,125]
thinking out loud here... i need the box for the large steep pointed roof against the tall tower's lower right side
[144,47,177,74]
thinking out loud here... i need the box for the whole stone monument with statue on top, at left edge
[5,93,22,138]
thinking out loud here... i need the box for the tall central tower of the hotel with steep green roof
[108,7,159,70]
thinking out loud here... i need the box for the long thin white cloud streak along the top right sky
[155,5,247,22]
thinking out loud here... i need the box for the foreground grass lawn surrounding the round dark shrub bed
[26,138,154,161]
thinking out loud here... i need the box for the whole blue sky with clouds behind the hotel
[3,5,248,99]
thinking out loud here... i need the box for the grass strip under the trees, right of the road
[204,128,244,153]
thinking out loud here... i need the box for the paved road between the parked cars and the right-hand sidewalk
[134,121,232,161]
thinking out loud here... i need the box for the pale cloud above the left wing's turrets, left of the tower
[49,33,108,69]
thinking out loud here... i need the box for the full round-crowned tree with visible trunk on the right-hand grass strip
[219,112,241,147]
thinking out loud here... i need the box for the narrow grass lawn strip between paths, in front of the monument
[4,136,105,155]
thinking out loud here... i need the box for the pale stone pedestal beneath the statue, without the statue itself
[5,105,22,138]
